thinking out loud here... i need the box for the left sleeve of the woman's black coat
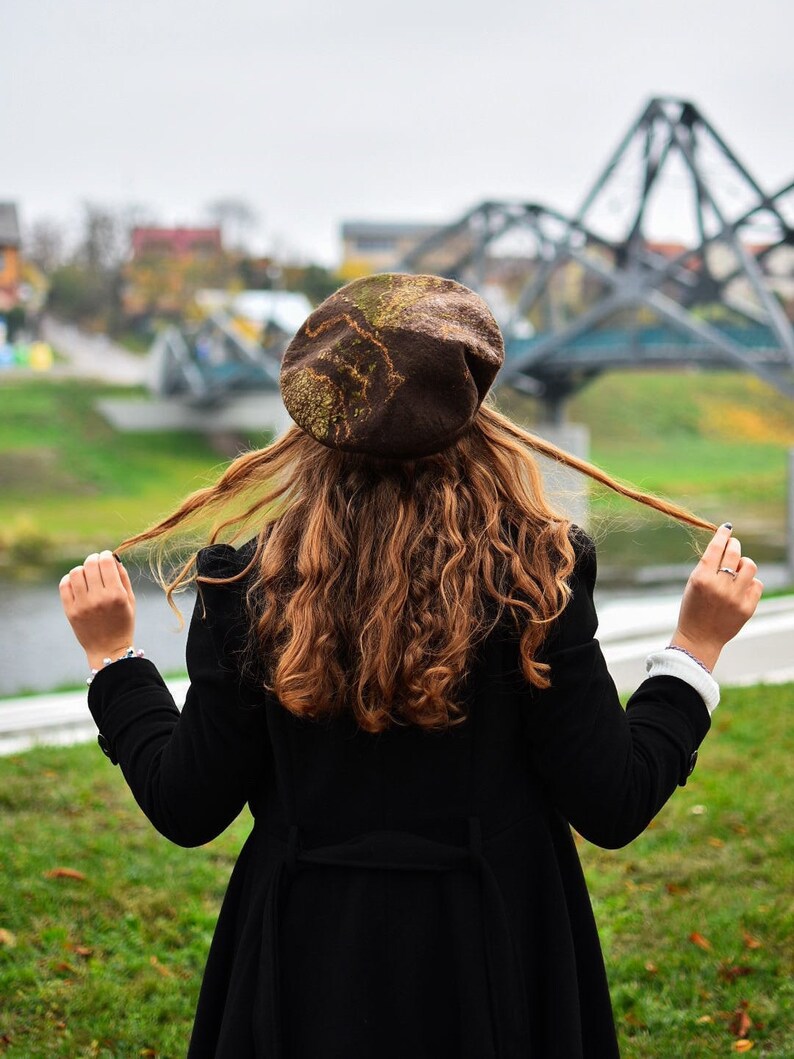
[88,545,267,846]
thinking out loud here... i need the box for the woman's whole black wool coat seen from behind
[89,541,709,1059]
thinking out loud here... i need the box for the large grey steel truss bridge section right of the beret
[399,98,794,419]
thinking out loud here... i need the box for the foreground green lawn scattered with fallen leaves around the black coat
[0,685,794,1059]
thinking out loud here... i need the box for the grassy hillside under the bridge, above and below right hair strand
[503,372,794,563]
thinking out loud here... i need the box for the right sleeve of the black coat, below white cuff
[528,534,710,848]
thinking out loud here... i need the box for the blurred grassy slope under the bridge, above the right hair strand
[571,372,794,531]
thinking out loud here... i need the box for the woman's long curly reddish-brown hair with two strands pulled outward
[121,405,715,732]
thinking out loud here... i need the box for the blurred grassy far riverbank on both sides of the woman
[0,373,794,569]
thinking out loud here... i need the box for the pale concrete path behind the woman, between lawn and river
[0,595,794,755]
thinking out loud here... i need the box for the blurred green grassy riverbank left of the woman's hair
[0,379,273,567]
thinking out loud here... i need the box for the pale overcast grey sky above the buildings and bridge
[6,0,794,262]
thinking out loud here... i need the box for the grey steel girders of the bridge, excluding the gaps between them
[399,97,794,400]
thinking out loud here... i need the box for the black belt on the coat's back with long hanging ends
[254,818,530,1059]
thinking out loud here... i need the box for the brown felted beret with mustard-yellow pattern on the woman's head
[281,272,504,460]
